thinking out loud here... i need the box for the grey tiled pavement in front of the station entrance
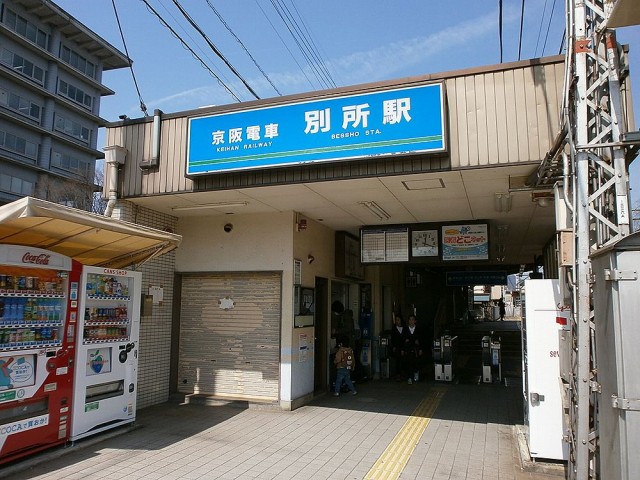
[0,380,564,480]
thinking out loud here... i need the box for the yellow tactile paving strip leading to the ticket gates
[364,386,447,480]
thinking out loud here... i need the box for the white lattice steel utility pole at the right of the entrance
[560,0,631,480]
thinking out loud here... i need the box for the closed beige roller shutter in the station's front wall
[178,272,281,400]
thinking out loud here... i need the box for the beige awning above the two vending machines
[0,197,182,268]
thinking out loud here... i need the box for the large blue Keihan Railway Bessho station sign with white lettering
[186,83,446,175]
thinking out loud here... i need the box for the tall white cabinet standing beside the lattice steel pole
[522,280,571,460]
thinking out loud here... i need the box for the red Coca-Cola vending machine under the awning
[0,245,82,464]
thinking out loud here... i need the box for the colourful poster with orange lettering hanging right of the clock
[442,223,489,260]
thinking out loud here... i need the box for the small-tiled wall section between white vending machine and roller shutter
[113,201,177,409]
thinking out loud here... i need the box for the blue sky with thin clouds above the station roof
[56,0,640,205]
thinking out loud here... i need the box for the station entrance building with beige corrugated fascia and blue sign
[105,56,632,409]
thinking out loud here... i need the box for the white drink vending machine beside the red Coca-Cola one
[71,266,142,441]
